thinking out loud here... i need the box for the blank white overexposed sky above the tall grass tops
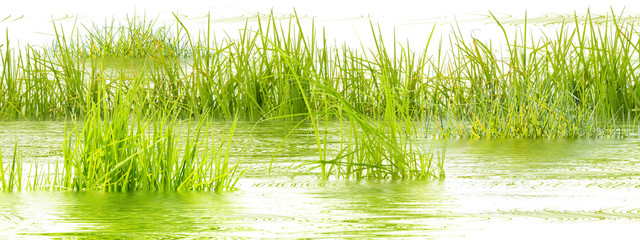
[0,0,640,44]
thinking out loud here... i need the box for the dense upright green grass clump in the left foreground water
[63,94,242,191]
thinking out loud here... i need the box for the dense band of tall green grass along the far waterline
[0,11,640,137]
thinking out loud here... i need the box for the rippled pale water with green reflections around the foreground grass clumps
[0,122,640,239]
